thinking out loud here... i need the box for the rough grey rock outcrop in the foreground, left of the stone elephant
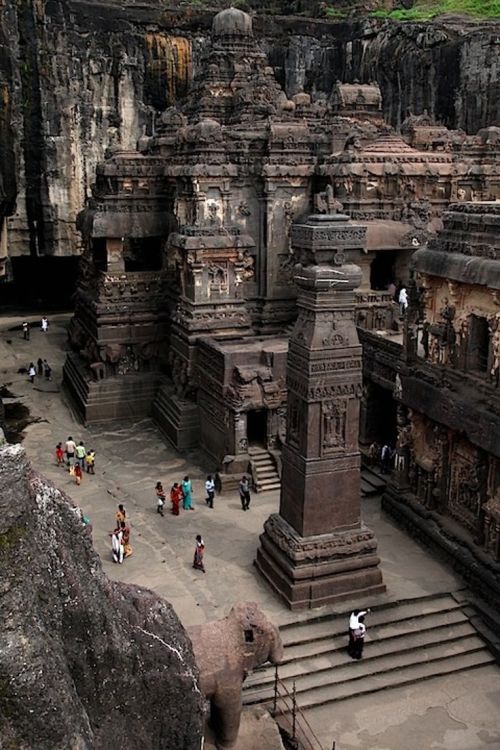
[0,446,203,750]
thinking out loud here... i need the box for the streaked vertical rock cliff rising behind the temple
[0,0,500,256]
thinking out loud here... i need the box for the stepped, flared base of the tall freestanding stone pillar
[255,513,385,610]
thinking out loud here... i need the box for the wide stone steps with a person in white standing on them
[243,594,495,710]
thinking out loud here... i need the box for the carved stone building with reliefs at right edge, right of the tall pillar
[385,202,500,600]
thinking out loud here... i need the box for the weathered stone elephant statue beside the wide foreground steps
[187,602,283,750]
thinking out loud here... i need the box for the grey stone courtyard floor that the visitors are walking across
[0,315,500,750]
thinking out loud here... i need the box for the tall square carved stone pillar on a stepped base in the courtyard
[256,214,385,609]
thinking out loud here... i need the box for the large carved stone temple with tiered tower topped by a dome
[64,9,500,482]
